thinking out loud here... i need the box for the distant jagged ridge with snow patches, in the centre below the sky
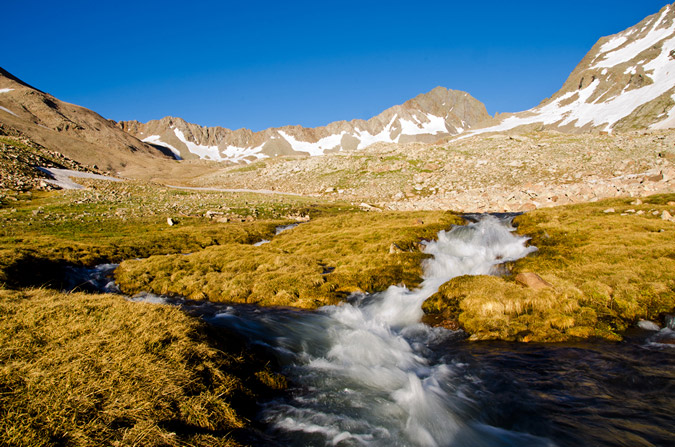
[119,87,492,162]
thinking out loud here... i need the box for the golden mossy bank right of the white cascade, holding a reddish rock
[424,194,675,341]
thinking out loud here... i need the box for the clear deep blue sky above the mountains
[0,0,668,130]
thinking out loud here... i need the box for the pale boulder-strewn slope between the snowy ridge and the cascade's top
[194,130,675,212]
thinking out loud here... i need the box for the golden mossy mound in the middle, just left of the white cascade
[115,211,461,308]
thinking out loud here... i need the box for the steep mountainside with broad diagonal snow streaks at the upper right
[464,4,675,135]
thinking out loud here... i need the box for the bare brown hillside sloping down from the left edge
[0,68,173,172]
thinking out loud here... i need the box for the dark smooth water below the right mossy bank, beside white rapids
[432,331,675,447]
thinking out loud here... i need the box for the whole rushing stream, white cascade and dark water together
[67,216,675,447]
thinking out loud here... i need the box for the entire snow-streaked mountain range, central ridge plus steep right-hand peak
[119,4,675,163]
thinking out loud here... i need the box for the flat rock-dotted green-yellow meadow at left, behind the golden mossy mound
[0,181,320,288]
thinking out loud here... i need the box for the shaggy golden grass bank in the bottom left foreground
[0,290,285,447]
